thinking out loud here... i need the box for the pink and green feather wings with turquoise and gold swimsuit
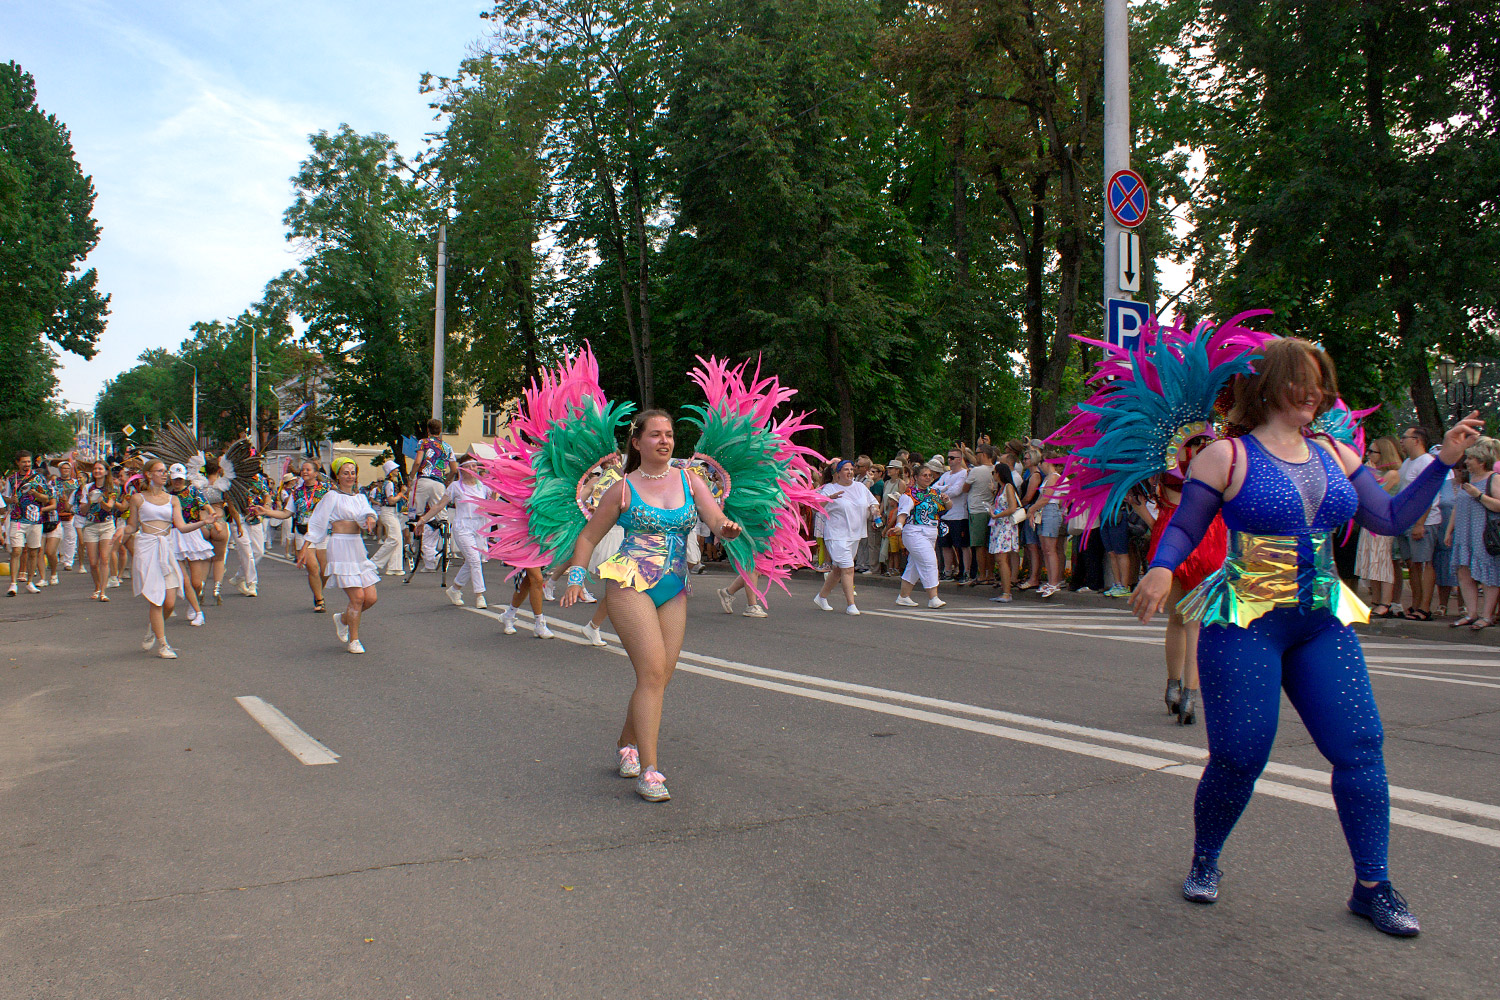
[479,346,822,607]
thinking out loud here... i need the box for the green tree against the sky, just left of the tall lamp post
[285,124,462,464]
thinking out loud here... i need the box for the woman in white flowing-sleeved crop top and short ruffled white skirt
[297,457,380,652]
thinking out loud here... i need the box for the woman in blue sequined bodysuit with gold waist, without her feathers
[1131,339,1482,936]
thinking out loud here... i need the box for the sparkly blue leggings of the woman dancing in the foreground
[1193,607,1391,882]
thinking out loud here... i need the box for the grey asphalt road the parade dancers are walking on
[0,561,1500,1000]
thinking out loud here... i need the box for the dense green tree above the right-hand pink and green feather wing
[666,0,924,454]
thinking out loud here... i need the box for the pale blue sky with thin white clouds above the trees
[0,0,489,409]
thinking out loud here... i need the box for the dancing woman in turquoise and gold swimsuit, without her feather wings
[563,409,740,802]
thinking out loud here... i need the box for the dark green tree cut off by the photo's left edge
[0,63,110,450]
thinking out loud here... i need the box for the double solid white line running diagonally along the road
[465,609,1500,847]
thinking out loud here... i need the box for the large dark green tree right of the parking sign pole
[1176,0,1500,430]
